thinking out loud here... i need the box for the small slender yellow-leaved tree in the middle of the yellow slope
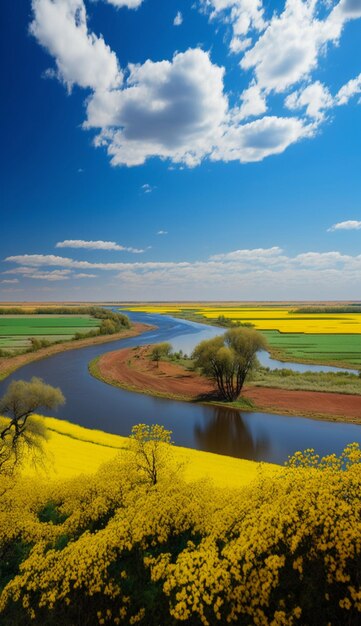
[130,424,172,485]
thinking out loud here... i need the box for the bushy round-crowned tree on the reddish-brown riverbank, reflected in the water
[192,328,267,402]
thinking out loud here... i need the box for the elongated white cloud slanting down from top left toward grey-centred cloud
[30,0,122,90]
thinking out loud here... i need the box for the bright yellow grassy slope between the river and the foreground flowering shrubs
[24,417,279,487]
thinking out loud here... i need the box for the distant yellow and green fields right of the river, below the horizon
[120,303,361,368]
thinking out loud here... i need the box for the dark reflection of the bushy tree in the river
[194,407,269,461]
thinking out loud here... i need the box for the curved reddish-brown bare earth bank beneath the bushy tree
[89,346,361,424]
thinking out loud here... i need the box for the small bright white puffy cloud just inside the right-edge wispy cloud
[285,81,334,120]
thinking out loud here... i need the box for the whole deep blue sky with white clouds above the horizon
[0,0,361,301]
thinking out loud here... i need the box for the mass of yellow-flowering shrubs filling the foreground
[0,444,361,626]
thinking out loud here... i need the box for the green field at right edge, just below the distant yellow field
[263,330,361,368]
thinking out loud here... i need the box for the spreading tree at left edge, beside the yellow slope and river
[0,377,65,474]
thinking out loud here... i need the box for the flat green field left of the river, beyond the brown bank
[0,315,101,352]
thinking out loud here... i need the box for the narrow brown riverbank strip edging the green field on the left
[0,322,150,380]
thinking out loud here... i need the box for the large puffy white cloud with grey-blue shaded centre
[85,48,228,166]
